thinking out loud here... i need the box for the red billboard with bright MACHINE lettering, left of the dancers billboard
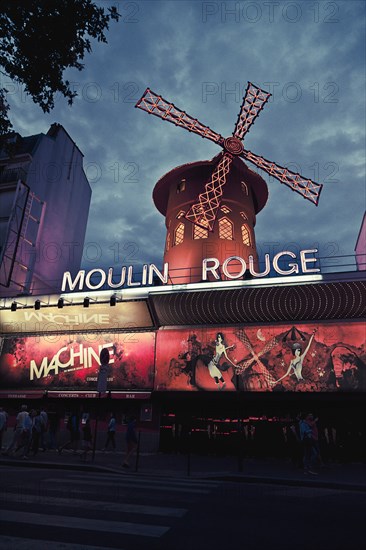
[0,332,155,391]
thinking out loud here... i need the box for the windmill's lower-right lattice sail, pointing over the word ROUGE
[240,149,323,206]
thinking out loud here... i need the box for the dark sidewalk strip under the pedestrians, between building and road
[0,450,366,492]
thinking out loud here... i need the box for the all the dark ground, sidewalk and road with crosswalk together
[0,450,366,550]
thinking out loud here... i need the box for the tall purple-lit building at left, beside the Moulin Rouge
[0,124,91,297]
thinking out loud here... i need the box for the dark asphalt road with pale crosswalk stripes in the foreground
[0,466,366,550]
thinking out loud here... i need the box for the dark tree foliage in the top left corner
[0,0,119,134]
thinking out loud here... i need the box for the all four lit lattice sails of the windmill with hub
[135,82,323,231]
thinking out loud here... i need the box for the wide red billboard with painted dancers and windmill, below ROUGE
[155,321,366,392]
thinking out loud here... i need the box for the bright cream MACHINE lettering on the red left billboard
[29,342,114,380]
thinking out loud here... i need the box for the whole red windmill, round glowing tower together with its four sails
[136,86,322,283]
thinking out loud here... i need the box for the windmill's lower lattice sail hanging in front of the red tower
[184,153,233,231]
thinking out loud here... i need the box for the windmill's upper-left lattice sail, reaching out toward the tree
[135,88,224,144]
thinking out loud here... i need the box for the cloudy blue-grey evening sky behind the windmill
[3,0,365,276]
